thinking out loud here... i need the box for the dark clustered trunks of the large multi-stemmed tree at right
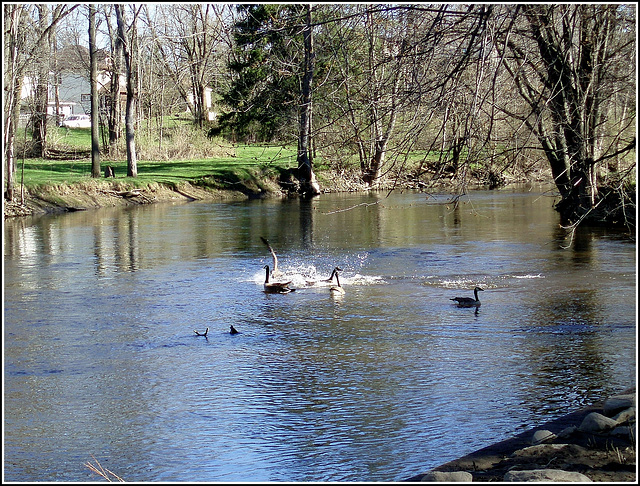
[524,5,615,223]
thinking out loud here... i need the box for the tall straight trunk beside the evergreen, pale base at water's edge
[297,5,320,197]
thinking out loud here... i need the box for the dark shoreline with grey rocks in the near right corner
[405,387,638,483]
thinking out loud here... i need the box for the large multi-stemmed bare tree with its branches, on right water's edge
[495,4,637,223]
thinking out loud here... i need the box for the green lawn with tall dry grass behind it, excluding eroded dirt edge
[17,124,295,190]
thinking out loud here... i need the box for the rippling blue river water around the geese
[4,188,637,482]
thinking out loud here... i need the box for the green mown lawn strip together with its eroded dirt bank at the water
[4,146,295,217]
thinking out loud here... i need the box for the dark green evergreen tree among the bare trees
[214,4,304,141]
